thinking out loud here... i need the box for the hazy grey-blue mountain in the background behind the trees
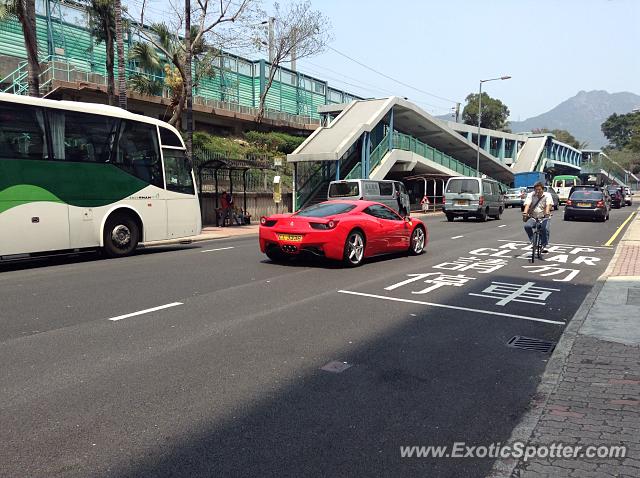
[509,90,640,149]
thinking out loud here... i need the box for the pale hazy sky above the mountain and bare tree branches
[131,0,640,120]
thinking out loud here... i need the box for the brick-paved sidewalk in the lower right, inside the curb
[491,207,640,478]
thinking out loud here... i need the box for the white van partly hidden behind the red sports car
[327,179,411,216]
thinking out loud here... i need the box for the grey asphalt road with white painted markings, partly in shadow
[0,208,631,477]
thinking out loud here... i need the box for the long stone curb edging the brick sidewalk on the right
[487,208,640,478]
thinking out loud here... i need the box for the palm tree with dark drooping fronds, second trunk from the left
[88,0,116,105]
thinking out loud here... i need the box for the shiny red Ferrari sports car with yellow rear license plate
[260,201,429,267]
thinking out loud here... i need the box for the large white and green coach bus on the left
[0,93,202,260]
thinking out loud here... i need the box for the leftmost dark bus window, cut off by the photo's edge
[0,103,48,159]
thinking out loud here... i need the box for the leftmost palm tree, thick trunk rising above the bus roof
[0,0,40,96]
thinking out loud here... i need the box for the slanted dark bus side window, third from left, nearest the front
[115,120,164,188]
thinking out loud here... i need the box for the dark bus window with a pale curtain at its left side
[47,109,118,163]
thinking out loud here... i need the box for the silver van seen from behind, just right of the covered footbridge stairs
[443,176,505,221]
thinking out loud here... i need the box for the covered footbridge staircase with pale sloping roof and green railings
[287,96,513,208]
